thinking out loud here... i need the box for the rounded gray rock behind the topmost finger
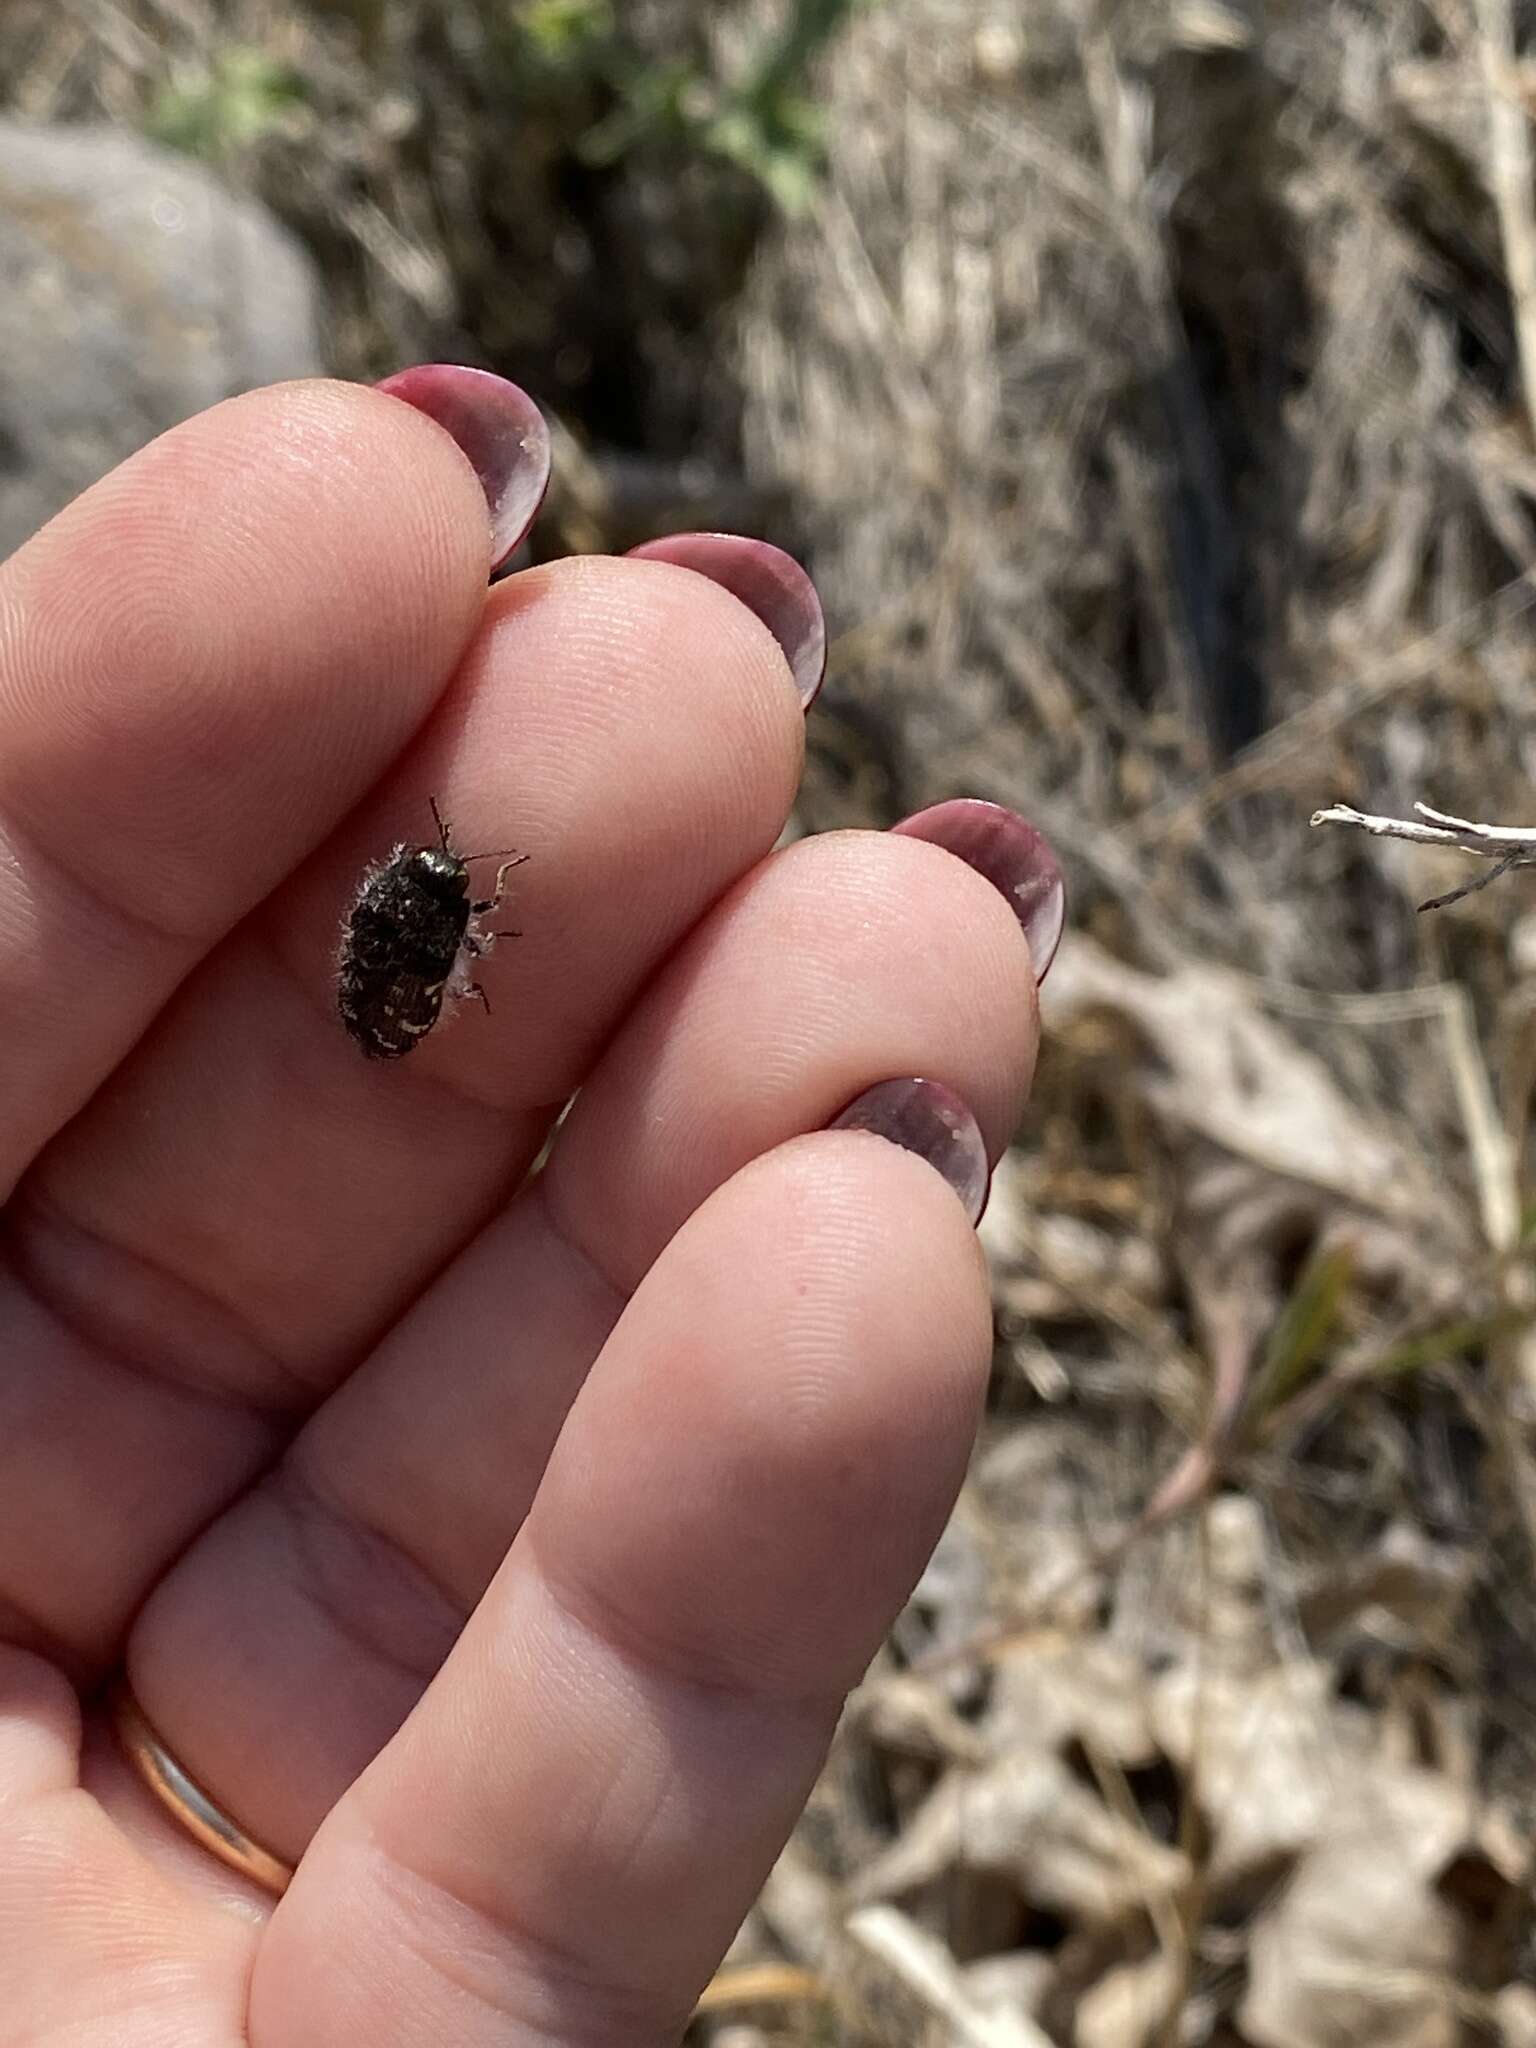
[0,121,322,559]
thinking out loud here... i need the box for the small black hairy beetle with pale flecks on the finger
[336,797,528,1059]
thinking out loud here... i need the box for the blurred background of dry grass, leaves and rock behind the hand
[0,0,1536,2048]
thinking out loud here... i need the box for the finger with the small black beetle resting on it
[0,561,803,1661]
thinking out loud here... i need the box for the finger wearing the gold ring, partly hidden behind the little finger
[129,815,1036,1860]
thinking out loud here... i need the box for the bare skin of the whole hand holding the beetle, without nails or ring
[0,385,1034,2048]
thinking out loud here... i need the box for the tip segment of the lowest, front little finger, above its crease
[530,1130,991,1698]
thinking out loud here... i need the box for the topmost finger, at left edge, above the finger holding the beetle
[0,383,524,1198]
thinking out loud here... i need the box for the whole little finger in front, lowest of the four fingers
[250,1135,991,2048]
